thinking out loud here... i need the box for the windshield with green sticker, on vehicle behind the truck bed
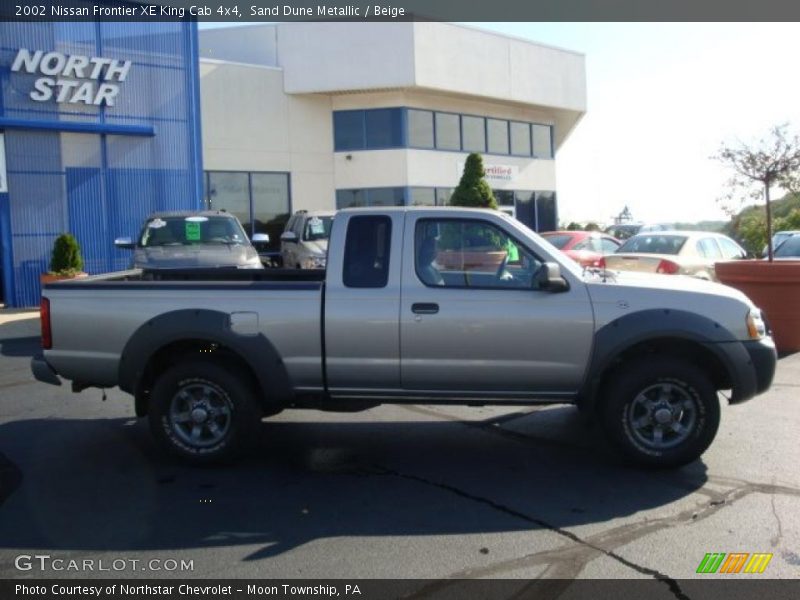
[139,216,247,248]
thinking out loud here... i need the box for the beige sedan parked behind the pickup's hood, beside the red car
[604,231,747,281]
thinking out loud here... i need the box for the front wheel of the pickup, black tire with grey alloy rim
[599,356,720,468]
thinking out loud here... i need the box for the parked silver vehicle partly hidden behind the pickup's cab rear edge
[281,210,334,269]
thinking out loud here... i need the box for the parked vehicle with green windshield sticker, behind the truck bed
[114,211,269,269]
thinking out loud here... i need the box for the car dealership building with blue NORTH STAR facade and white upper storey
[0,22,586,306]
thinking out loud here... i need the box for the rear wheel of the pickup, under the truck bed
[148,359,261,465]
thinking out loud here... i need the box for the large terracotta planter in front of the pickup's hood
[715,260,800,352]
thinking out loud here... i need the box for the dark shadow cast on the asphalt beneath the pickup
[0,407,706,560]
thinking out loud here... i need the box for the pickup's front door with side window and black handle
[400,212,594,398]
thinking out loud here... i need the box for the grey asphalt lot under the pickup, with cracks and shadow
[0,313,800,580]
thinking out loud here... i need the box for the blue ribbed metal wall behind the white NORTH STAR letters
[0,22,202,306]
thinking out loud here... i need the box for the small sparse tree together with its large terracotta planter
[714,125,800,352]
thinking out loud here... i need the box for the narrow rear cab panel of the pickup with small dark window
[324,211,405,396]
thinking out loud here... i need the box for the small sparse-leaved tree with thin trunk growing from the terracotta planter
[712,124,800,261]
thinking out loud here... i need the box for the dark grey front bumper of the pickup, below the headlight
[720,337,778,404]
